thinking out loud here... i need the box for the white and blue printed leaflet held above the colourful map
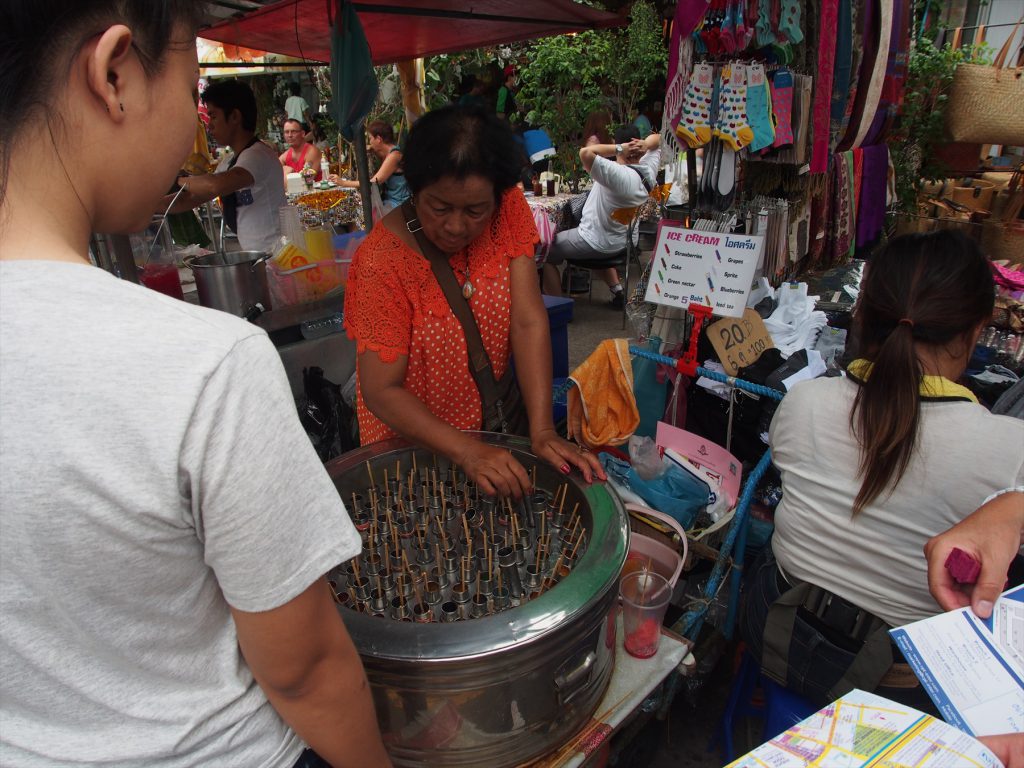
[890,587,1024,736]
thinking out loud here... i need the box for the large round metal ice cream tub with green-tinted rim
[327,433,629,768]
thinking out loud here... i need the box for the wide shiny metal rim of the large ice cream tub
[326,433,630,662]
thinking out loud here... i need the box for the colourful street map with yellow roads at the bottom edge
[728,690,1002,768]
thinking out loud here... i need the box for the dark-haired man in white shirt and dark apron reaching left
[168,80,288,256]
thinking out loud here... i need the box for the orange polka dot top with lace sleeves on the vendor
[345,187,539,445]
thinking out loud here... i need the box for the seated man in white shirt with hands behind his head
[544,125,662,307]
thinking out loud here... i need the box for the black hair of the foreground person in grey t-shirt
[0,0,203,204]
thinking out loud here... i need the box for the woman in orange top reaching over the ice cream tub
[345,108,603,497]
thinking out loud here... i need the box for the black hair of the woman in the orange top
[402,106,527,203]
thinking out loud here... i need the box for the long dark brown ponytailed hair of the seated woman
[850,230,995,515]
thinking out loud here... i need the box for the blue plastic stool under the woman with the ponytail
[708,650,820,763]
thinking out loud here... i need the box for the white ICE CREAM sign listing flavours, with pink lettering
[644,221,764,317]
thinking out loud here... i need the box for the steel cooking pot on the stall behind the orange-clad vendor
[184,251,270,317]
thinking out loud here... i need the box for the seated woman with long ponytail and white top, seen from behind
[742,231,1024,709]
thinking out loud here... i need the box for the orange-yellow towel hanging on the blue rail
[568,339,640,447]
